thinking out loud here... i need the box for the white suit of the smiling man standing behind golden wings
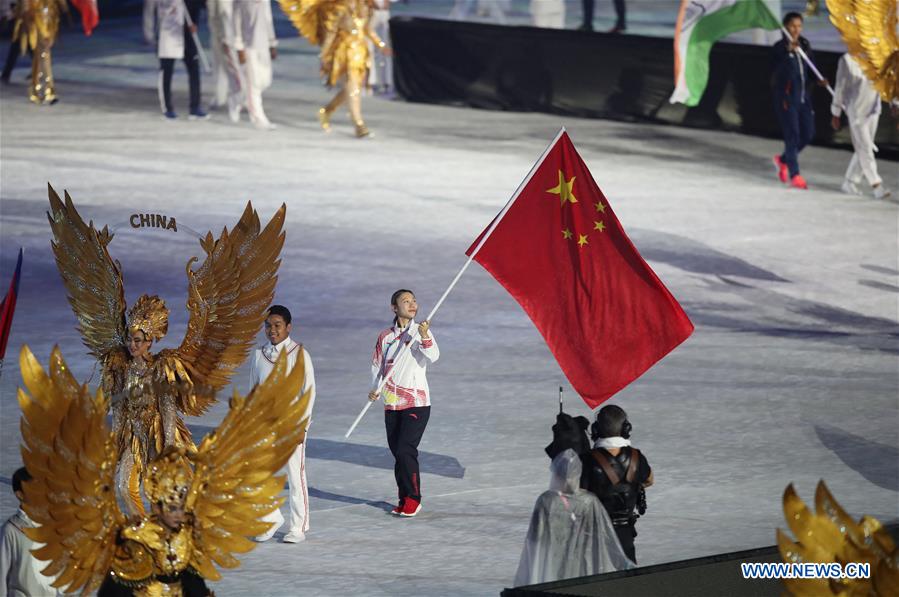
[250,337,315,533]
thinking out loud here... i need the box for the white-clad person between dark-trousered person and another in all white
[206,0,243,122]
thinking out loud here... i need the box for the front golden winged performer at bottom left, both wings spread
[18,346,310,597]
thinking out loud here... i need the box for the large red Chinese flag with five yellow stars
[466,131,693,408]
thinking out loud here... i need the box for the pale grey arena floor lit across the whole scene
[0,10,899,595]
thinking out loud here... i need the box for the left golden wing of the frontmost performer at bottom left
[18,346,125,594]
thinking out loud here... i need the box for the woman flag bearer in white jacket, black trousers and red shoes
[368,289,440,517]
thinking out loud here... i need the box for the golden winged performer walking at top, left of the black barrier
[278,0,391,137]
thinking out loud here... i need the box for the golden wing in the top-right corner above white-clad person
[827,0,899,102]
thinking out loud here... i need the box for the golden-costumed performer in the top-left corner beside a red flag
[12,0,69,104]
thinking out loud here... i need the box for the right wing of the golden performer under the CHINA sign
[167,203,287,415]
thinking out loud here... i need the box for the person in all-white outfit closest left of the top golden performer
[234,0,278,130]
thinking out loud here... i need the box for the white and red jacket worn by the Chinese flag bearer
[371,320,440,410]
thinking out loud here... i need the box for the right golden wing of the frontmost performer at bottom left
[186,351,311,580]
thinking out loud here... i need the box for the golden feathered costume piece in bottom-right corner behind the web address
[777,481,899,597]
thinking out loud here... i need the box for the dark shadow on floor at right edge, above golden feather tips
[815,425,899,491]
